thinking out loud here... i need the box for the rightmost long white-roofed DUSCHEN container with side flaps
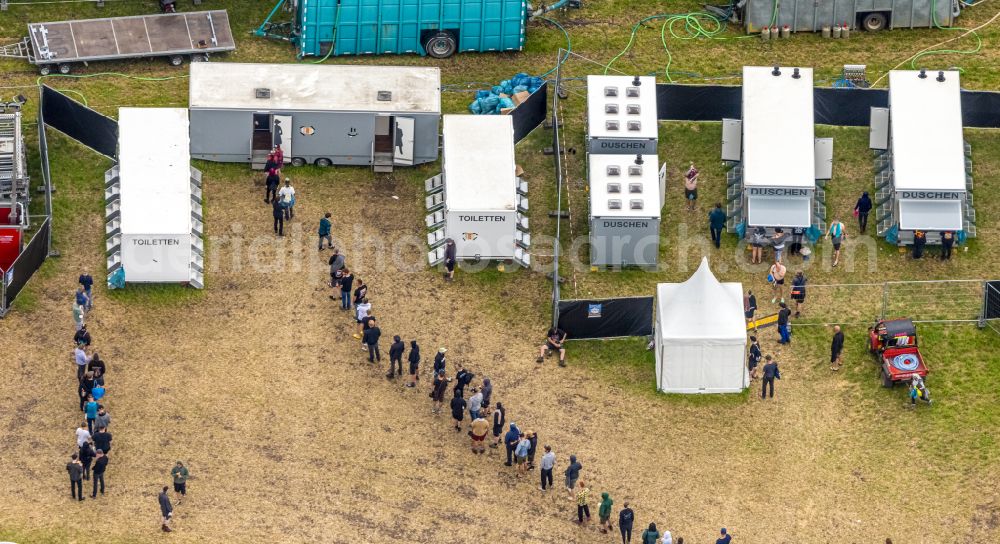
[869,70,976,246]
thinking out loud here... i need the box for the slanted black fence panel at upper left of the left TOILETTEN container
[41,85,118,158]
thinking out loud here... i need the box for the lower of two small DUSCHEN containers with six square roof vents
[587,154,665,268]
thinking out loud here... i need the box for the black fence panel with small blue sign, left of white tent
[559,297,653,340]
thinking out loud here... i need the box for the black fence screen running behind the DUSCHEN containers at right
[656,83,1000,128]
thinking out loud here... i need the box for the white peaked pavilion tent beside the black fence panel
[655,258,750,393]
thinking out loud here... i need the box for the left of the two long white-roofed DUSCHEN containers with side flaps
[722,66,833,237]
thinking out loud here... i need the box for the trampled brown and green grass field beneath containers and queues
[0,0,1000,544]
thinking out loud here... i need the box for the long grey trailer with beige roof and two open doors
[190,62,441,172]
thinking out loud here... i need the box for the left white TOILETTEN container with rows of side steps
[105,108,204,289]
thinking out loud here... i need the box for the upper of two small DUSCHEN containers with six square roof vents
[587,75,658,155]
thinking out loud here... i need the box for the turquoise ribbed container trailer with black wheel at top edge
[254,0,581,58]
